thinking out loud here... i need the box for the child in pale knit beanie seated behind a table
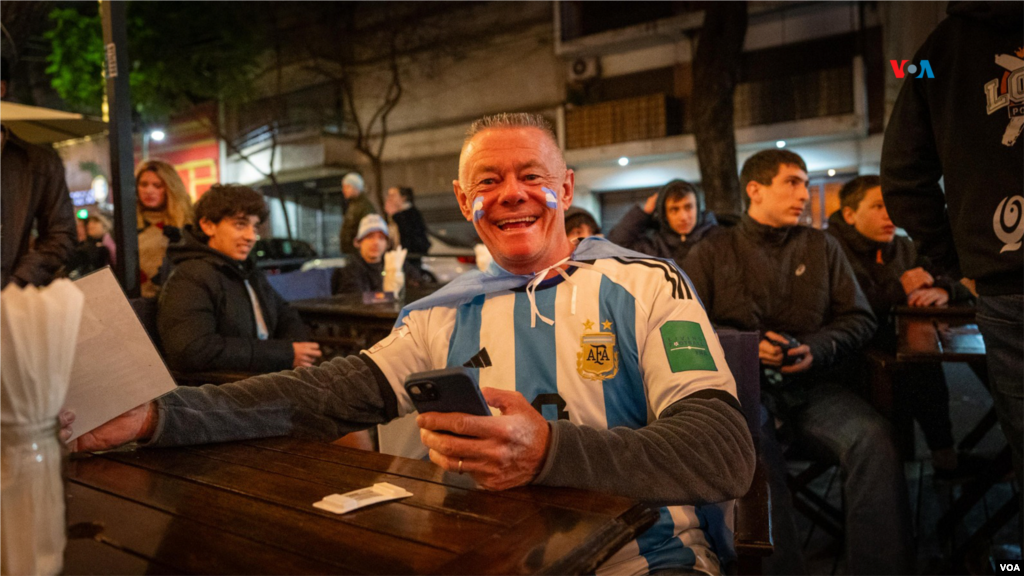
[331,214,423,294]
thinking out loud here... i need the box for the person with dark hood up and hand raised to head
[608,179,718,265]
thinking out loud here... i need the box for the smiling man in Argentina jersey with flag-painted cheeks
[66,114,754,575]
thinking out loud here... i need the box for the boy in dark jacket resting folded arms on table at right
[828,175,972,480]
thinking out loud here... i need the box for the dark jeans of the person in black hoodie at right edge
[977,294,1024,549]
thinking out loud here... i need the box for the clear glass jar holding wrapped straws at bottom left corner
[0,421,67,576]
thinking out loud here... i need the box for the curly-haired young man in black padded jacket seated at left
[157,184,321,372]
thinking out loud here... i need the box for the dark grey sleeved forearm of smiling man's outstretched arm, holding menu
[148,357,396,446]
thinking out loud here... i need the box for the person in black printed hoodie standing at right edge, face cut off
[882,0,1024,545]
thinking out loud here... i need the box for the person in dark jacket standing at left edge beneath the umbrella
[0,57,77,289]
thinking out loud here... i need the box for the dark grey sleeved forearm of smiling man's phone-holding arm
[534,398,755,506]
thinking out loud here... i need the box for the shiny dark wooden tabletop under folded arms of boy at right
[896,306,985,362]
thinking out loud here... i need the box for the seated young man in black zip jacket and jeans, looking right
[684,150,912,576]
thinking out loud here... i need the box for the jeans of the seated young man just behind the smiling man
[761,383,914,576]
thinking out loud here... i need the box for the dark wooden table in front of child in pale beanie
[290,288,436,355]
